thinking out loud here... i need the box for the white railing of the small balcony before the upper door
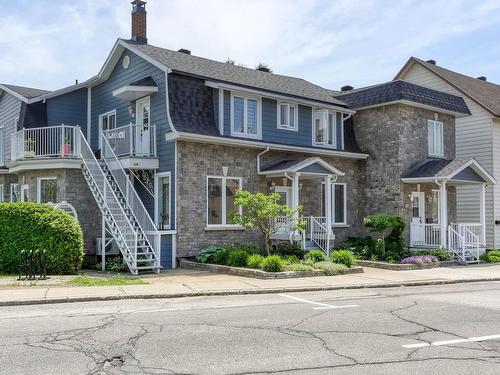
[104,124,156,157]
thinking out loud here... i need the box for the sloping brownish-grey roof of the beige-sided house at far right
[398,57,500,116]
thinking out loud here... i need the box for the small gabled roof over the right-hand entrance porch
[401,159,496,185]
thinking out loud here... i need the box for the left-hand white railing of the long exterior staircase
[81,131,144,274]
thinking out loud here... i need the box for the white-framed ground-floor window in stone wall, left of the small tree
[207,176,242,227]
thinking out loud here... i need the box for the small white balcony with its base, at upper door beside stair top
[103,124,159,169]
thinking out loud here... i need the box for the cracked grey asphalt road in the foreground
[0,283,500,375]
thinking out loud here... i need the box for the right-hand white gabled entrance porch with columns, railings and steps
[401,159,496,261]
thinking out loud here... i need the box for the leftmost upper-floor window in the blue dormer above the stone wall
[231,93,261,139]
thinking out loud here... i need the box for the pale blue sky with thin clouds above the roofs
[0,0,500,89]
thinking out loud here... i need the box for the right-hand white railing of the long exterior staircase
[102,134,160,266]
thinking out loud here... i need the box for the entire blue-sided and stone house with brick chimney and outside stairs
[0,0,494,273]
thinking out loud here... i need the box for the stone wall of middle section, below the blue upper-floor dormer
[177,141,361,257]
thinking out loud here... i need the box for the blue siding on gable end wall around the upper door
[91,50,170,152]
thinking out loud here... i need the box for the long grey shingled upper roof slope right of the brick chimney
[125,40,345,106]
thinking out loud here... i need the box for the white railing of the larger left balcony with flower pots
[11,124,81,161]
